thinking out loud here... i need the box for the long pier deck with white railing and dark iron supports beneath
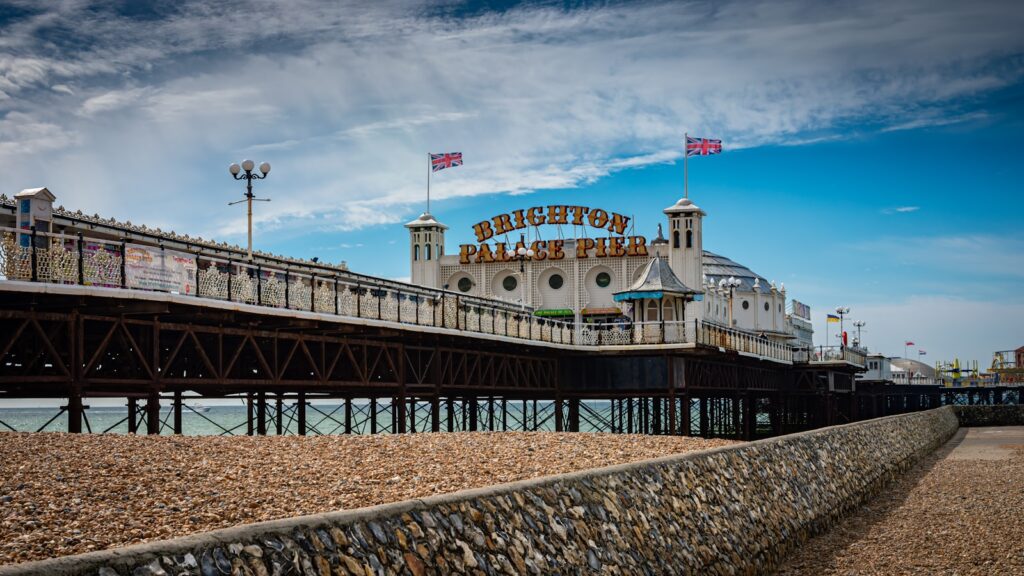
[0,189,1007,438]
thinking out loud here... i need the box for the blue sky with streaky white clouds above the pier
[0,0,1024,366]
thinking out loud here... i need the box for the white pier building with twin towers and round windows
[406,193,813,346]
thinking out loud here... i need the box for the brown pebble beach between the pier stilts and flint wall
[0,433,734,564]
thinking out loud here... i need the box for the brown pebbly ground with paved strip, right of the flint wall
[777,426,1024,576]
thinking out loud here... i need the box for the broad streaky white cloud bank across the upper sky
[0,0,1024,235]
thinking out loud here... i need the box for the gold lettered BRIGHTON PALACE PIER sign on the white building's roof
[459,205,647,264]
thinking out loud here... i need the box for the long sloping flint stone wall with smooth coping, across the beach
[0,408,957,576]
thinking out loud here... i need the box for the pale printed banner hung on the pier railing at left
[125,244,197,294]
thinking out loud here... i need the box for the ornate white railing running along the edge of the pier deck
[0,227,794,363]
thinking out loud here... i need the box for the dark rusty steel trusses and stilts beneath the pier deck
[0,291,1024,439]
